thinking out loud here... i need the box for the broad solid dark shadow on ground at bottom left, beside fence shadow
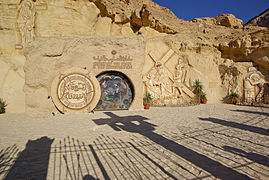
[5,137,54,180]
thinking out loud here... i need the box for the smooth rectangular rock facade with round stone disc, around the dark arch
[24,36,145,114]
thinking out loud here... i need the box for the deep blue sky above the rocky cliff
[153,0,269,23]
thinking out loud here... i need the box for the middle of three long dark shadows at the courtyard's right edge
[199,117,269,136]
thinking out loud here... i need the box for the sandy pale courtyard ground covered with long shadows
[0,105,269,180]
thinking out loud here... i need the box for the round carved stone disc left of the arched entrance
[51,68,100,113]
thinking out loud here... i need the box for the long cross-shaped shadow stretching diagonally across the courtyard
[93,112,250,179]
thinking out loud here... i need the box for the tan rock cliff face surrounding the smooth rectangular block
[0,0,269,112]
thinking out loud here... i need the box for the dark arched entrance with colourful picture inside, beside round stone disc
[95,71,134,110]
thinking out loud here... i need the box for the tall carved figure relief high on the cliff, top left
[17,0,35,46]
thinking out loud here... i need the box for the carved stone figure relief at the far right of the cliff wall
[245,67,265,101]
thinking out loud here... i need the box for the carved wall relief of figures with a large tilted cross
[143,49,195,105]
